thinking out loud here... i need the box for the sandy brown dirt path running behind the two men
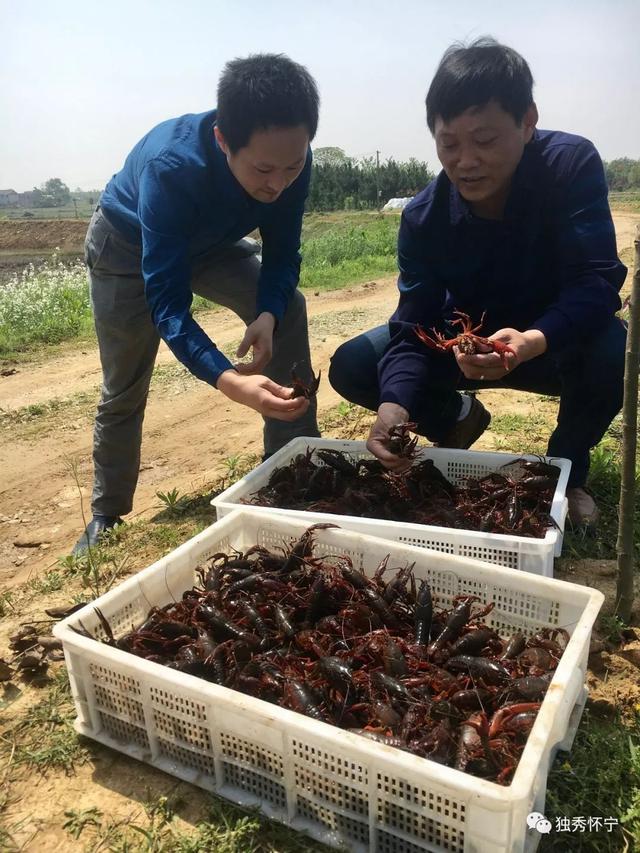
[0,213,640,589]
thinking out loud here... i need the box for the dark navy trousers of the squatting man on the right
[329,317,626,486]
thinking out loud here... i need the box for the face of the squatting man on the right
[434,101,538,219]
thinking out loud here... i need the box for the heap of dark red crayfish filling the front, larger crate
[77,524,569,784]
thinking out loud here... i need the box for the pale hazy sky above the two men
[0,0,640,192]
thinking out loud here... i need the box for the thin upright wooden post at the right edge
[616,226,640,623]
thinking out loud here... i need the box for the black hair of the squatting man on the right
[426,36,533,133]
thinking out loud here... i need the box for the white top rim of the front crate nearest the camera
[53,508,604,812]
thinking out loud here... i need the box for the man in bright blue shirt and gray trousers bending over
[74,54,319,554]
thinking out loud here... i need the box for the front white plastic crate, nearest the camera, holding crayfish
[54,509,603,853]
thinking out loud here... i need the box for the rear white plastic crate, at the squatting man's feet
[211,438,571,578]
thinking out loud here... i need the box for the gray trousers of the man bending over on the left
[85,209,319,516]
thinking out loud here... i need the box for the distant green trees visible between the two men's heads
[307,147,434,210]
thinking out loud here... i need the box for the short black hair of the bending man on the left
[216,53,320,153]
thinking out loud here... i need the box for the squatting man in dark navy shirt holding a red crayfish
[329,39,626,525]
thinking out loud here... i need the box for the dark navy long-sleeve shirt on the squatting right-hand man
[379,130,627,413]
